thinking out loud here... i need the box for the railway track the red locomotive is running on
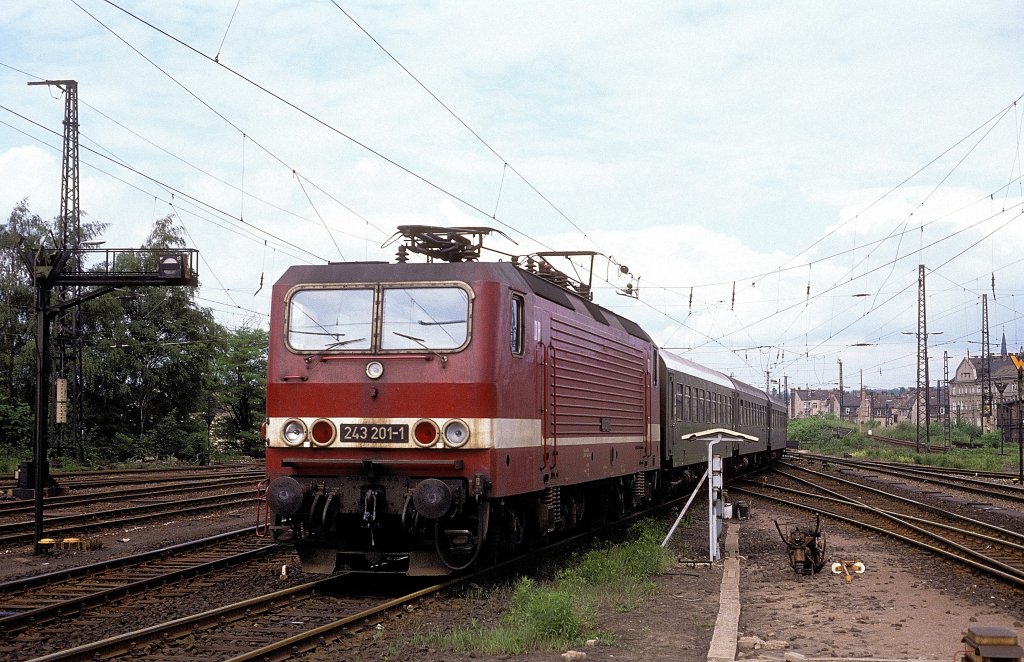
[0,479,704,661]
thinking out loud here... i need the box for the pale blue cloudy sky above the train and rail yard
[0,0,1024,389]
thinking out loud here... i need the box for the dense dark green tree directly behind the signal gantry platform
[83,216,221,461]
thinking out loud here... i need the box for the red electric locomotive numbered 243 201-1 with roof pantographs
[263,226,662,575]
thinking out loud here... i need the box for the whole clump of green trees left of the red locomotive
[0,200,267,464]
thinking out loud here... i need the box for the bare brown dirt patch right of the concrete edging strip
[738,505,1024,660]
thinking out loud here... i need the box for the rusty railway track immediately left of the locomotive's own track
[0,527,281,639]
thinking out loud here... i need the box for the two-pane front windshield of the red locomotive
[288,286,469,351]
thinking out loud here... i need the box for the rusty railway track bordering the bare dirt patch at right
[730,462,1024,587]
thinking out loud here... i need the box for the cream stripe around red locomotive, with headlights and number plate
[266,417,660,449]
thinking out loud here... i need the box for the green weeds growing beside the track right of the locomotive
[414,520,673,655]
